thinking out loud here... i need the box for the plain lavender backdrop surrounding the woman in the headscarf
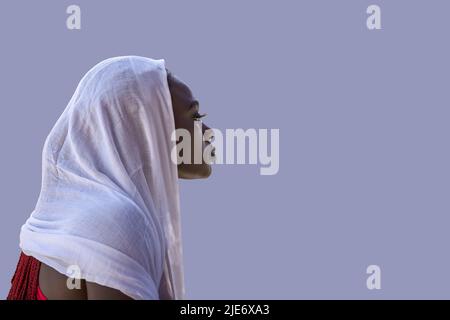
[0,0,450,299]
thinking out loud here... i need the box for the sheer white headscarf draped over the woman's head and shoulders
[20,56,184,299]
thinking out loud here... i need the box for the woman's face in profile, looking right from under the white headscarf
[167,71,211,179]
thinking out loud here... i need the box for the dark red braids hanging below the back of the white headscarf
[6,252,47,300]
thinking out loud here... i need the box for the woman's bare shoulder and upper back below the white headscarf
[39,263,131,300]
